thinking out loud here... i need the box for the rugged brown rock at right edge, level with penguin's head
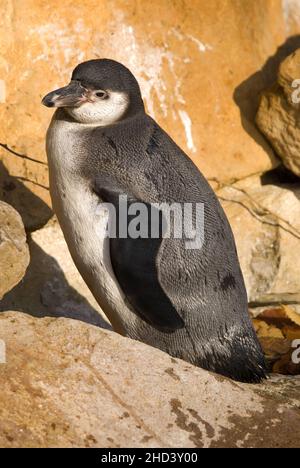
[256,49,300,176]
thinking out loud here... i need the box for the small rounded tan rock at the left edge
[0,201,29,300]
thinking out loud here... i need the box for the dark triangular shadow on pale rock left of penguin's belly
[0,241,111,329]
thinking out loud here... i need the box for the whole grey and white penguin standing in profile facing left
[42,59,266,383]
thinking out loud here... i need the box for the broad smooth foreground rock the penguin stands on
[0,313,300,448]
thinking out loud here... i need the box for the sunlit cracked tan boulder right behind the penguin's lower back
[217,176,300,312]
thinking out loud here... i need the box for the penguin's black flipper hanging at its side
[97,188,185,333]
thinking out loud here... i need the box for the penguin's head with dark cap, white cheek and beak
[42,59,144,126]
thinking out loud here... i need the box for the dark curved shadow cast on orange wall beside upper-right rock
[233,35,300,160]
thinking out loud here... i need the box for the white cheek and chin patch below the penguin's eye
[66,91,129,126]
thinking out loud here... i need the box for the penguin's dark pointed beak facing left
[42,81,88,107]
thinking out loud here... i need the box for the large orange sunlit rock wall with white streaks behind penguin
[0,0,299,216]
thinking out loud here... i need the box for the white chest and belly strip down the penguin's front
[47,115,134,333]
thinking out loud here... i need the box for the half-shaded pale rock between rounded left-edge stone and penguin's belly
[0,218,110,328]
